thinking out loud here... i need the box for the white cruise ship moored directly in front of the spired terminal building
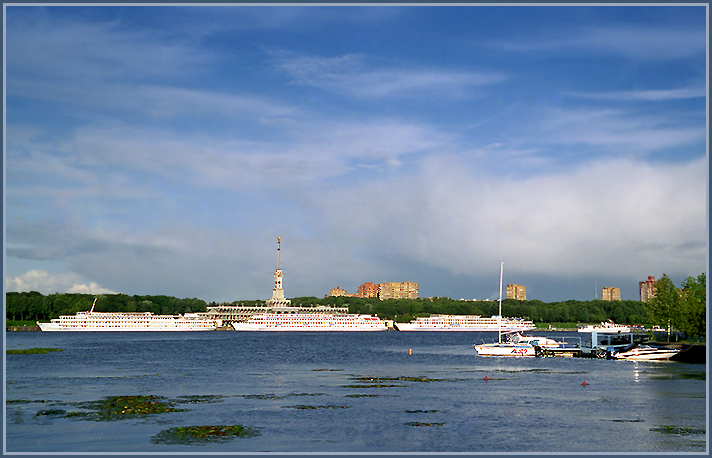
[232,313,388,331]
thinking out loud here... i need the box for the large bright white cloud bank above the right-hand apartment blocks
[316,157,706,278]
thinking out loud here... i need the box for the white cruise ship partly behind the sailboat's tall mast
[396,315,536,332]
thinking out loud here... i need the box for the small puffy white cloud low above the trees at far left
[5,269,116,294]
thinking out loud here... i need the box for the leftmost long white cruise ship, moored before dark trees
[37,300,217,331]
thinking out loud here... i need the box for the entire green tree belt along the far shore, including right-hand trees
[5,272,707,337]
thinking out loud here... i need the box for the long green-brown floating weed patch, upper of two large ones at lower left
[65,396,185,421]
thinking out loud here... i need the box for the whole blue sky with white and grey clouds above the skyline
[4,4,709,302]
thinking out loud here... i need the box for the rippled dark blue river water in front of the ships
[5,331,708,454]
